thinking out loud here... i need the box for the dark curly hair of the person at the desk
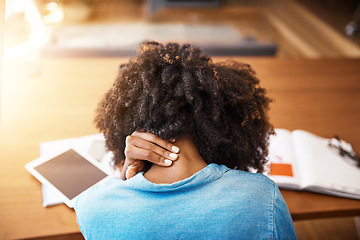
[95,42,274,172]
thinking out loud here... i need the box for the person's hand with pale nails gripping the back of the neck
[120,131,180,180]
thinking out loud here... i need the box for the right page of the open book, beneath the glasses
[293,130,360,196]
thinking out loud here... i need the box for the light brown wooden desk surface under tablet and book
[0,58,360,239]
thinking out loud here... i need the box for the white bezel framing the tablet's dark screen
[25,148,112,208]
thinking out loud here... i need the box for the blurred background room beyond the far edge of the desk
[4,0,360,59]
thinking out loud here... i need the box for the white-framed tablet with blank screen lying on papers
[25,149,110,208]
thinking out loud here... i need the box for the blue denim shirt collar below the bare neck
[125,163,229,192]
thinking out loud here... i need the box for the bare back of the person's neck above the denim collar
[144,136,207,184]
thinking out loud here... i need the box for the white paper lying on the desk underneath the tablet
[40,134,119,207]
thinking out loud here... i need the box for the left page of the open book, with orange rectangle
[269,128,301,189]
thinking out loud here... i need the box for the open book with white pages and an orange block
[269,129,360,199]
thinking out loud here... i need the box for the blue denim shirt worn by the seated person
[75,164,296,240]
